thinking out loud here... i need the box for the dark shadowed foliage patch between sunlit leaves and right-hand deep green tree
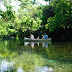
[42,6,54,25]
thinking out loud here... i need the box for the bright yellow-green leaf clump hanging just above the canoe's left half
[21,16,41,31]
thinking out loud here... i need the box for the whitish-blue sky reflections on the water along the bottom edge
[0,59,54,72]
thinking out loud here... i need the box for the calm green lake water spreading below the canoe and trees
[0,39,72,72]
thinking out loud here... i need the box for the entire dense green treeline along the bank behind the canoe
[0,0,72,41]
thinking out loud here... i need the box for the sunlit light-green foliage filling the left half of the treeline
[0,0,42,37]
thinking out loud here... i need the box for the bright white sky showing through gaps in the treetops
[0,0,49,12]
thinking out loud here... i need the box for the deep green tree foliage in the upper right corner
[46,0,71,31]
